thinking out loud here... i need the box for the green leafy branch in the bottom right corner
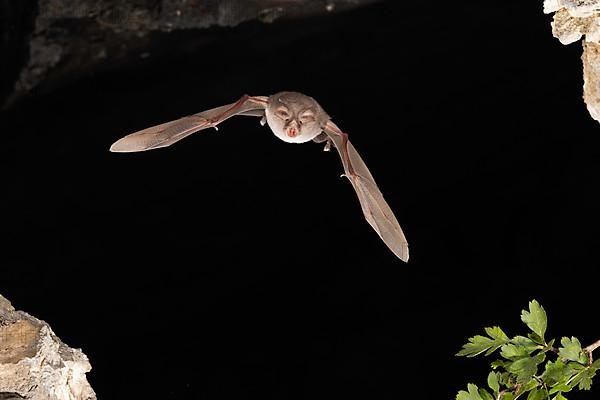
[456,300,600,400]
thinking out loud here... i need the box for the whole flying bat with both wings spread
[110,92,408,262]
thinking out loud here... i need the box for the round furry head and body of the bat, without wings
[265,92,329,143]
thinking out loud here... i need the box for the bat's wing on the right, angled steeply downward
[323,121,408,262]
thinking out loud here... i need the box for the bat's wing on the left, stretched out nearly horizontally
[110,95,267,153]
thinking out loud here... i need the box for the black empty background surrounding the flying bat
[0,1,600,399]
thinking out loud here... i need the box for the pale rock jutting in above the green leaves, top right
[544,0,600,122]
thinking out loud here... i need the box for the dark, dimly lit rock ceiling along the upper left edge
[0,0,377,105]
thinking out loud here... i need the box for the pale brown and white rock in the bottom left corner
[0,295,96,400]
